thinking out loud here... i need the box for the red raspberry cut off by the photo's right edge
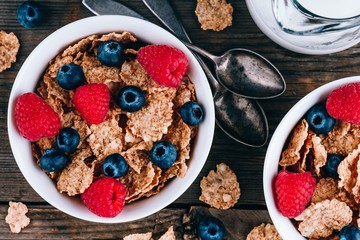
[326,82,360,124]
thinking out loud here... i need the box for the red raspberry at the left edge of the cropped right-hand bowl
[275,170,316,218]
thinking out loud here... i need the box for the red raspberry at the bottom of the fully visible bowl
[82,177,126,218]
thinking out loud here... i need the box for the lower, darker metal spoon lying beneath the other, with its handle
[143,0,269,147]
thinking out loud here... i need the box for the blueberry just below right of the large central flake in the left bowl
[150,141,177,169]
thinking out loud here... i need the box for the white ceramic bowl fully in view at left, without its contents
[8,16,215,223]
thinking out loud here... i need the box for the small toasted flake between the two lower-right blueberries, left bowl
[122,142,151,173]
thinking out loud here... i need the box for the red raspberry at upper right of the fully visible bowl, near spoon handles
[137,45,189,87]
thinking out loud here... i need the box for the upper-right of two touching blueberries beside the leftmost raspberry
[56,127,80,153]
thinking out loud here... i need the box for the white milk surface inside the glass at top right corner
[294,0,360,18]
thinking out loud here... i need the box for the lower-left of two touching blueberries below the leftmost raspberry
[40,148,69,172]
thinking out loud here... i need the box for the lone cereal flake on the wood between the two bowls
[199,163,240,209]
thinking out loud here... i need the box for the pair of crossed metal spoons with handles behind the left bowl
[83,0,285,147]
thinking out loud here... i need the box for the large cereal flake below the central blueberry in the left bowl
[127,92,173,142]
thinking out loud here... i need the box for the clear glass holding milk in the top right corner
[272,0,360,37]
